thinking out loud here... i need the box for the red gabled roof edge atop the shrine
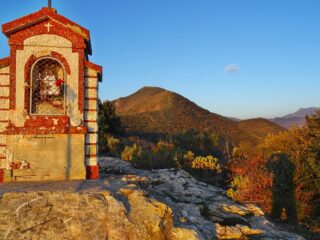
[2,8,92,54]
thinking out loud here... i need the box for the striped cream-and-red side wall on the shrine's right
[84,68,99,170]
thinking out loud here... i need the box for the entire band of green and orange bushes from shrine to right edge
[99,99,320,231]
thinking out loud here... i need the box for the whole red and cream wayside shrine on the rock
[0,4,102,182]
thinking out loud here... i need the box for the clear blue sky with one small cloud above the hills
[0,0,320,118]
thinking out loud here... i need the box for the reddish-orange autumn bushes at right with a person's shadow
[228,112,320,231]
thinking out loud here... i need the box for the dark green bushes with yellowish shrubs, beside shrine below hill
[99,101,225,184]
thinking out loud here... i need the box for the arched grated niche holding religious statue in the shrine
[30,58,65,115]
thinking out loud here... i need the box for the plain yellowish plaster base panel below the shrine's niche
[4,134,86,182]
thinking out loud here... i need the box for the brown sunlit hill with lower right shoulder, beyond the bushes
[114,87,284,144]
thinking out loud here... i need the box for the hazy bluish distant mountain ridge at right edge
[269,107,320,129]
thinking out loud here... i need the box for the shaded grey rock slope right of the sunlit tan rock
[100,158,303,240]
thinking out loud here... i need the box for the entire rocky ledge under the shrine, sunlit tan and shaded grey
[0,158,303,240]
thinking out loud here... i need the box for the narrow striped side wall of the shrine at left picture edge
[0,66,10,169]
